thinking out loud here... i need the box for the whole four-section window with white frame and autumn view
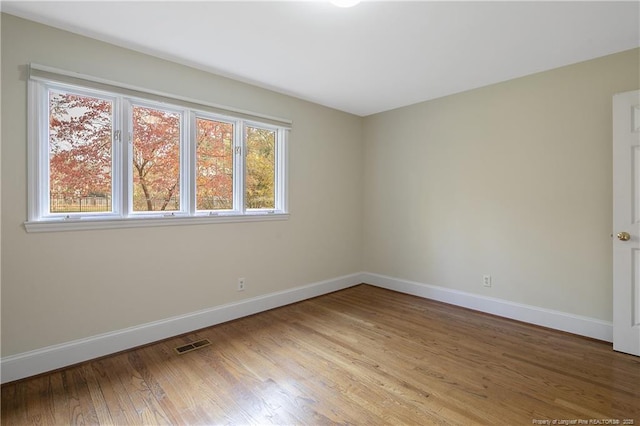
[25,65,288,231]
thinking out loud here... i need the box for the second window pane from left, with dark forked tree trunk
[133,106,180,211]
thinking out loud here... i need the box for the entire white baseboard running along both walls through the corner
[0,272,613,383]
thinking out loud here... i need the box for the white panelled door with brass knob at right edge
[613,90,640,356]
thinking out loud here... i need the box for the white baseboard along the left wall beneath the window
[0,274,362,383]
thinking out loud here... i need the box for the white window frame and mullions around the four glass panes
[24,64,291,232]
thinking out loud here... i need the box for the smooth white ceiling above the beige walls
[1,0,640,116]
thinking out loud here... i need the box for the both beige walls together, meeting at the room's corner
[0,11,640,357]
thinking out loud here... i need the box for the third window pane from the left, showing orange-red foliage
[196,118,233,210]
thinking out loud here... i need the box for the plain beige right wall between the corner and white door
[363,49,640,321]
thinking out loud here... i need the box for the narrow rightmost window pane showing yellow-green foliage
[246,127,276,209]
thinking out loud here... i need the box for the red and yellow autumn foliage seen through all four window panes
[49,91,275,212]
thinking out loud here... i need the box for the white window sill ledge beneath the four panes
[24,213,289,232]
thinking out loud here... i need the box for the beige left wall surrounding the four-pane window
[1,15,362,356]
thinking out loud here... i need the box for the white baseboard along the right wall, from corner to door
[361,273,613,342]
